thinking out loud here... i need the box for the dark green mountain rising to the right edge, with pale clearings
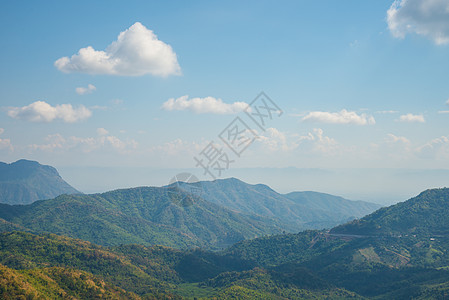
[224,189,449,299]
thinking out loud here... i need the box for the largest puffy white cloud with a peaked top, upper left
[55,22,181,77]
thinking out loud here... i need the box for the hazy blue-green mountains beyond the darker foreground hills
[0,160,379,250]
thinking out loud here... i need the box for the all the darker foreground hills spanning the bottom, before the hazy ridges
[0,189,449,299]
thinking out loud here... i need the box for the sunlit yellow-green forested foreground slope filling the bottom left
[0,232,358,299]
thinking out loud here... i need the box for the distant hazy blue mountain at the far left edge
[0,159,79,204]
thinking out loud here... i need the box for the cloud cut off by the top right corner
[387,0,449,45]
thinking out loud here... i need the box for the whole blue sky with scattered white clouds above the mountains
[0,0,449,203]
